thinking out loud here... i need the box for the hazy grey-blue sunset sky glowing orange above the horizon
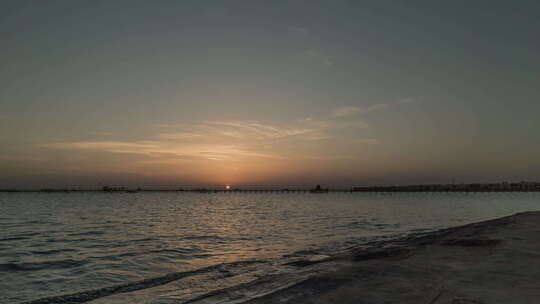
[0,0,540,188]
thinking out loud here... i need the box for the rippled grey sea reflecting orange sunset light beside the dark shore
[0,192,540,303]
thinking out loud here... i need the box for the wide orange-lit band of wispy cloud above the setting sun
[41,118,373,161]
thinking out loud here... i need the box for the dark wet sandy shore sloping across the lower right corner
[237,212,540,304]
